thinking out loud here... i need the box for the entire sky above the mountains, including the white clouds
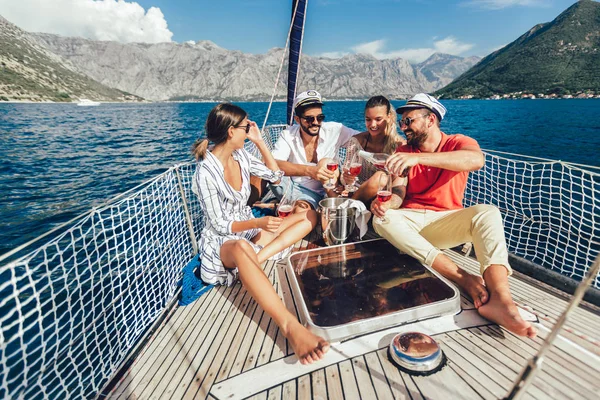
[0,0,592,62]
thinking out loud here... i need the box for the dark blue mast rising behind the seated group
[287,0,308,125]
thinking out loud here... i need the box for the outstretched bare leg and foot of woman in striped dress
[221,240,329,364]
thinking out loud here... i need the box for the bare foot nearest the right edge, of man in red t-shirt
[477,293,537,339]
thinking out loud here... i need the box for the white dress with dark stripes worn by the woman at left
[192,149,283,285]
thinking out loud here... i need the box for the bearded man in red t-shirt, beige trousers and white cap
[371,93,536,338]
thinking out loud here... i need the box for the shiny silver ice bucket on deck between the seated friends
[319,197,356,246]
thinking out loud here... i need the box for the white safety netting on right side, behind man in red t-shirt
[465,150,600,288]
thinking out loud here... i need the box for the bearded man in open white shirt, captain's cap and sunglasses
[265,90,359,209]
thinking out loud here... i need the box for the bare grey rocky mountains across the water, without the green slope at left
[35,34,474,101]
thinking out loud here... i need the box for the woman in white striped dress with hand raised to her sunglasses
[193,103,329,364]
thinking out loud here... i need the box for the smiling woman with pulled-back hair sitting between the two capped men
[340,96,406,208]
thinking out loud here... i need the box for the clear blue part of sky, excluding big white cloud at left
[131,0,574,60]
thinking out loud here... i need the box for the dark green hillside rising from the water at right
[436,0,600,98]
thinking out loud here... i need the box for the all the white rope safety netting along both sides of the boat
[0,126,600,399]
